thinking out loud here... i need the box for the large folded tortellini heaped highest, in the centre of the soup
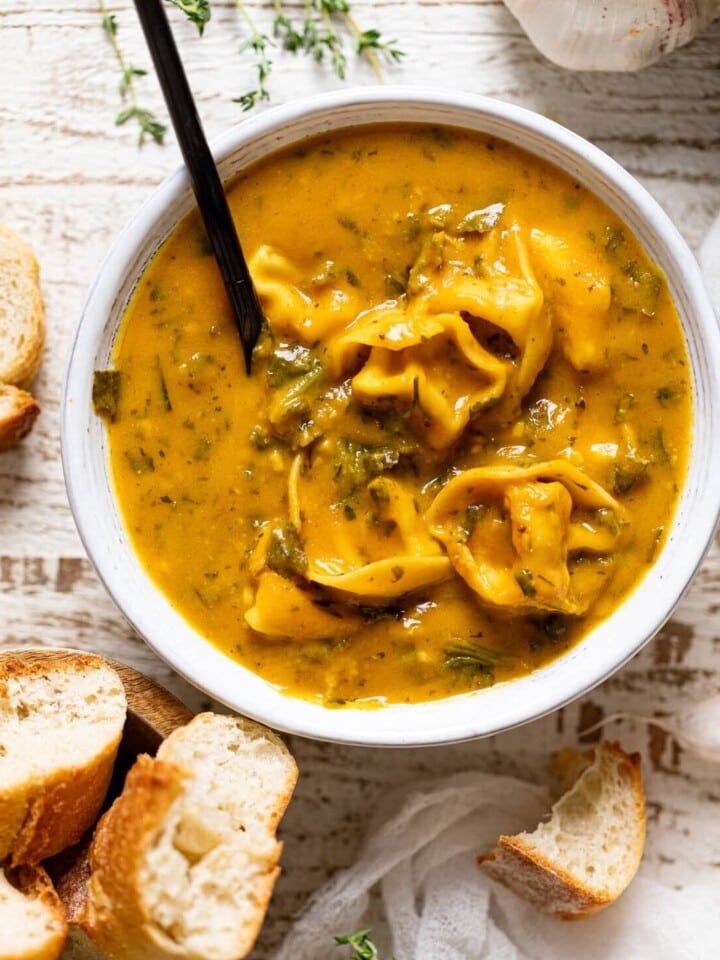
[327,227,552,449]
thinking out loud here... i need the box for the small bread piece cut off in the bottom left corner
[0,867,67,960]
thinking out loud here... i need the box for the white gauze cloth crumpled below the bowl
[273,773,720,960]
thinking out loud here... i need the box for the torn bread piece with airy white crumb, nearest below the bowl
[82,714,297,960]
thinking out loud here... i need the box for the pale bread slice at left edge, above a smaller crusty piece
[0,225,45,387]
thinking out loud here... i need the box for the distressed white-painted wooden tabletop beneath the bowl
[0,0,720,958]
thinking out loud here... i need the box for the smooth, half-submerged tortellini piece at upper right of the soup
[530,230,611,371]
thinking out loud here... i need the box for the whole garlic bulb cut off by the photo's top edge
[505,0,720,70]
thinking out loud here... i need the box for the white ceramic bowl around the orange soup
[62,87,720,745]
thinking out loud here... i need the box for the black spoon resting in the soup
[135,0,264,374]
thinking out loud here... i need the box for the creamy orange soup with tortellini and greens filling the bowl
[94,126,692,704]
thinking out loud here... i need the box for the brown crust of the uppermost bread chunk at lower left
[0,653,122,867]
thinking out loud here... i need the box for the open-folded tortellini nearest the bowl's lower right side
[428,460,624,615]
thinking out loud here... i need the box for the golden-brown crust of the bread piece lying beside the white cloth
[478,743,645,920]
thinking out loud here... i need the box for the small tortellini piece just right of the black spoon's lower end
[249,245,360,344]
